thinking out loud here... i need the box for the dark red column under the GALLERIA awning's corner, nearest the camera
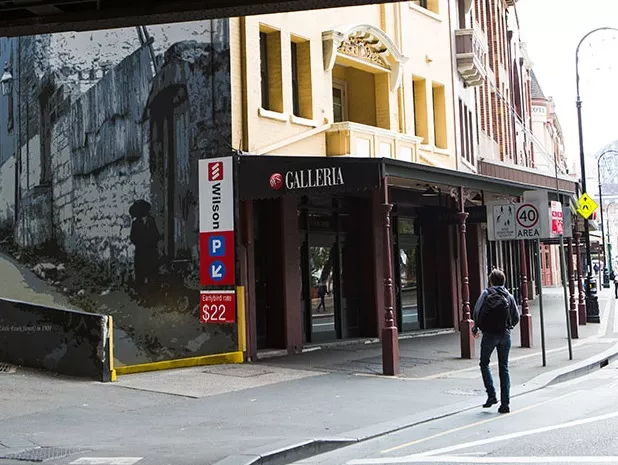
[382,177,399,376]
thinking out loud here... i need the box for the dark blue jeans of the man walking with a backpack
[480,331,511,406]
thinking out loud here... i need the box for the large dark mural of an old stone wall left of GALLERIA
[0,19,237,365]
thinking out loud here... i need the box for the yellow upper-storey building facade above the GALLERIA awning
[230,0,458,169]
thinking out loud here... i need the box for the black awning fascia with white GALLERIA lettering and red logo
[238,155,382,200]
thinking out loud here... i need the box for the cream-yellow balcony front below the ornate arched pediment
[326,121,422,162]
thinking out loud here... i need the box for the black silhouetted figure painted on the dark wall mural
[129,200,161,292]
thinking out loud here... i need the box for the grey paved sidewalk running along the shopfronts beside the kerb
[0,288,618,465]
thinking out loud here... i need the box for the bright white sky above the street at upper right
[516,0,618,178]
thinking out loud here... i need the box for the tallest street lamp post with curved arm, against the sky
[575,27,618,323]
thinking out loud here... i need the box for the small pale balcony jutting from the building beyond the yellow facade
[455,26,487,86]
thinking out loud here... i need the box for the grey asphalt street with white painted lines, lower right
[296,364,618,465]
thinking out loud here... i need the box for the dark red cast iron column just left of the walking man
[457,188,474,358]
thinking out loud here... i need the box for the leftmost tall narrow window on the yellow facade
[260,31,283,113]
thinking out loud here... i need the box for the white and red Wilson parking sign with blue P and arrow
[199,157,236,286]
